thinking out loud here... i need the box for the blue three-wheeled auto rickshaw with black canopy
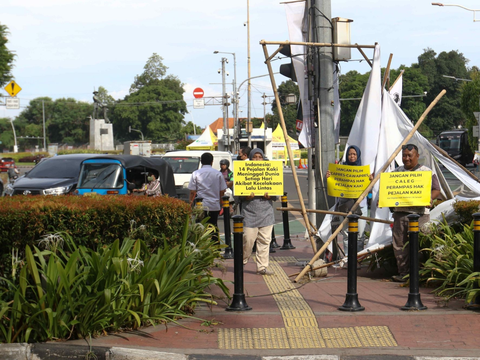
[76,155,176,197]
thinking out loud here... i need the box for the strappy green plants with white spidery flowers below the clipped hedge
[0,216,228,343]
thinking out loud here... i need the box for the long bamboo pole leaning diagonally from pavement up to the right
[294,90,446,282]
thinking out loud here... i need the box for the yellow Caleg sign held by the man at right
[378,171,432,207]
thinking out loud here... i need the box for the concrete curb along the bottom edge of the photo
[0,343,480,360]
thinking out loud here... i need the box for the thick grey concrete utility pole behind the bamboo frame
[310,0,335,224]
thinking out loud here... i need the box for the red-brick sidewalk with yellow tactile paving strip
[0,229,480,360]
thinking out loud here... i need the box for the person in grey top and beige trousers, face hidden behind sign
[239,148,277,275]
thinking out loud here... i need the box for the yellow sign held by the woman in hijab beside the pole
[327,164,370,199]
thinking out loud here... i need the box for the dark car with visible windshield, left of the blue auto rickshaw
[5,154,100,196]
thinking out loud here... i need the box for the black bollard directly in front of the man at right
[400,214,427,310]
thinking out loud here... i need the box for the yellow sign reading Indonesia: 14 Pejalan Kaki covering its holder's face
[233,160,283,196]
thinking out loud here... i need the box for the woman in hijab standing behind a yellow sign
[326,145,373,255]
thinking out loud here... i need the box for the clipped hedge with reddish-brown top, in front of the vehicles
[0,195,191,276]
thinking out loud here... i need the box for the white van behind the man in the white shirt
[162,150,233,202]
